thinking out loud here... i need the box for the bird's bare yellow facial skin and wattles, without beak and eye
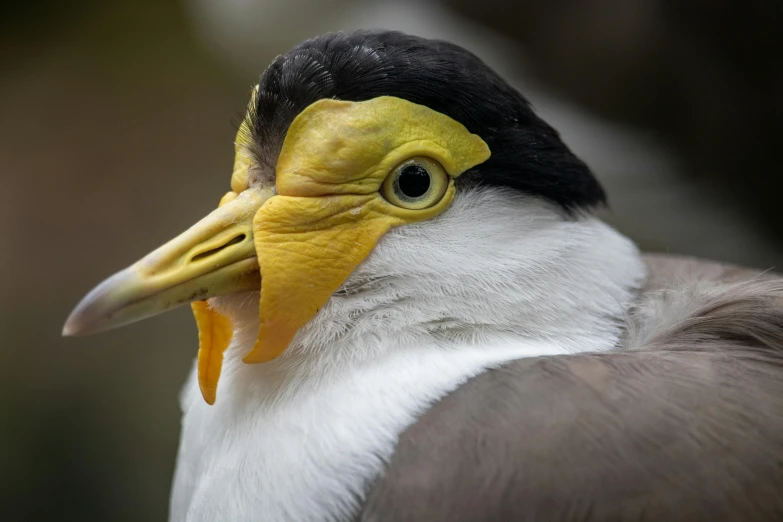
[193,92,490,394]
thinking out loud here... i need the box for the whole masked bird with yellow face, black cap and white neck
[63,30,783,522]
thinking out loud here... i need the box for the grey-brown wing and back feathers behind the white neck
[358,254,783,522]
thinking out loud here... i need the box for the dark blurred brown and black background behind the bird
[0,0,783,521]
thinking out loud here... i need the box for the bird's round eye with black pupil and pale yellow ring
[381,156,449,210]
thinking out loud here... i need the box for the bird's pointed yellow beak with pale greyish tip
[63,188,272,335]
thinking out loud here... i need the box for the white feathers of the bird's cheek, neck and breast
[171,190,645,521]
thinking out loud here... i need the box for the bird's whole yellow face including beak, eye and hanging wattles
[66,92,490,404]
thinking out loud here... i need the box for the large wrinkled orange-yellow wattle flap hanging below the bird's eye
[250,194,410,363]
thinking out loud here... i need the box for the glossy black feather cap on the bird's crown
[245,31,606,211]
